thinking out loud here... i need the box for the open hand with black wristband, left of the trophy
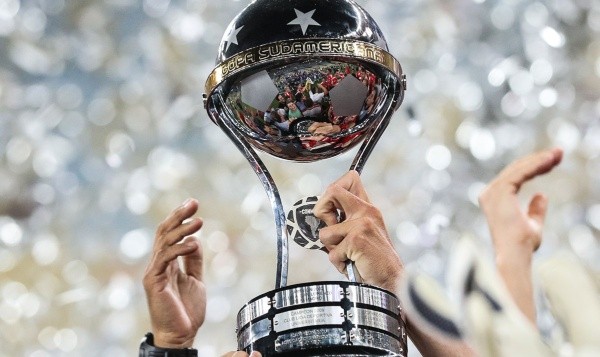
[143,199,206,348]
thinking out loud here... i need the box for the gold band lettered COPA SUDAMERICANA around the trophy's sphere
[204,38,402,95]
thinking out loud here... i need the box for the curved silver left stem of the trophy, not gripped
[220,113,289,289]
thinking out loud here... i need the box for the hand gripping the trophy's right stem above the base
[313,171,403,292]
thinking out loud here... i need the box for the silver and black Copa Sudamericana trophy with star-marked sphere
[204,0,407,356]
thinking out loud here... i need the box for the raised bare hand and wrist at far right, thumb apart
[479,148,562,324]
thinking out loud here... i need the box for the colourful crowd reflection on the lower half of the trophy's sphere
[229,63,381,150]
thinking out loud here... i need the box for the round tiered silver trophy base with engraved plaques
[237,281,407,357]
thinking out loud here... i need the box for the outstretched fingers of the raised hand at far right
[497,148,562,192]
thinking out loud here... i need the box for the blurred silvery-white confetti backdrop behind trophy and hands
[0,0,600,357]
